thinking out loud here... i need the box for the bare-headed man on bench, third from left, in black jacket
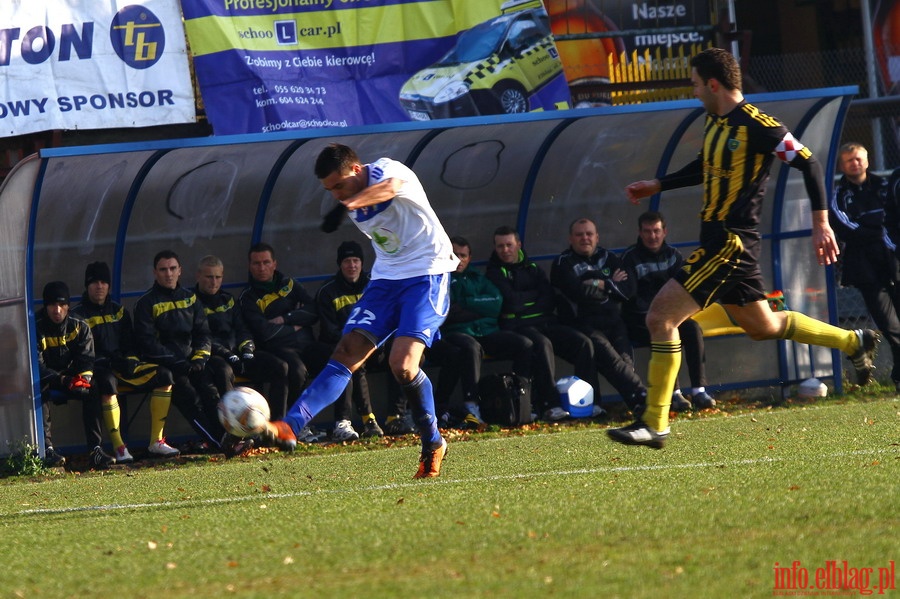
[134,250,225,456]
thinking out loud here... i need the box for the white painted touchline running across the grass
[8,449,893,518]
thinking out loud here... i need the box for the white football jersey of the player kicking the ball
[350,158,459,280]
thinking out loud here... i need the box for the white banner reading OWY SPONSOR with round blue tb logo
[0,0,196,137]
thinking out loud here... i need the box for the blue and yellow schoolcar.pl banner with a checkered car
[182,0,570,135]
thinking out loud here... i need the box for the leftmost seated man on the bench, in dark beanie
[35,281,106,468]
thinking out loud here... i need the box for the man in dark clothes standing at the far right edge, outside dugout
[828,143,900,390]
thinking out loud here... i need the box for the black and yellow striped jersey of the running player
[660,101,826,229]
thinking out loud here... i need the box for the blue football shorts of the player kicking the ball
[344,273,450,347]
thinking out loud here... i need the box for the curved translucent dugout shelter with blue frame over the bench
[0,87,857,453]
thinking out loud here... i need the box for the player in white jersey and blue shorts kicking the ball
[266,144,459,478]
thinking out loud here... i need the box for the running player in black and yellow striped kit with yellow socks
[608,48,879,449]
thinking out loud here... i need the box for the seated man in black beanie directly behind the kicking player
[316,241,384,441]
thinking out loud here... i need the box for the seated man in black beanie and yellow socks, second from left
[72,262,178,464]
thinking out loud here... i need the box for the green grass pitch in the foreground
[0,397,900,599]
